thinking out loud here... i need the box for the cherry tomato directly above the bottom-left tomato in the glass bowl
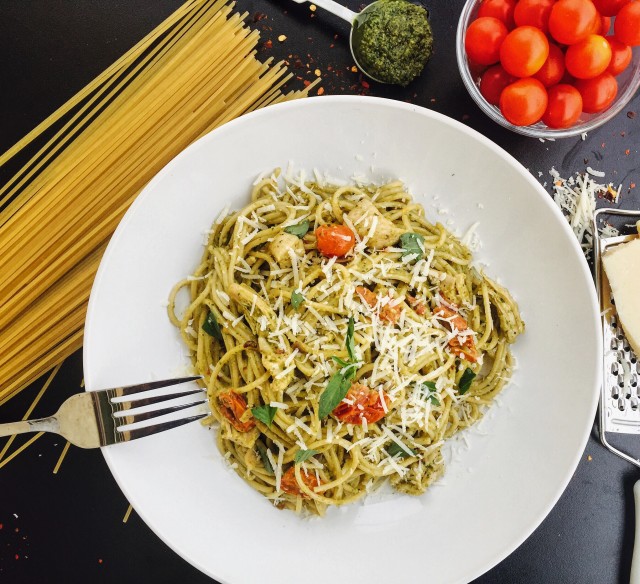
[500,26,549,77]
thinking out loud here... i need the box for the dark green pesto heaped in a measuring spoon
[352,0,433,86]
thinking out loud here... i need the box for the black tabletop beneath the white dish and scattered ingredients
[0,0,640,584]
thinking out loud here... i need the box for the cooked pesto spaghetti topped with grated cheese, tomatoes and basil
[169,171,524,514]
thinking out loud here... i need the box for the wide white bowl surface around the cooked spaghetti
[84,97,601,584]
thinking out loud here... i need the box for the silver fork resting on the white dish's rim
[0,377,207,448]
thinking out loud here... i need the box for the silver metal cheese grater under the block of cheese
[593,209,640,467]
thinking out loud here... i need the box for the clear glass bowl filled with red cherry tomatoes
[456,0,640,139]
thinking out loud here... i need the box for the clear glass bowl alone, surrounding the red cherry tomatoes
[456,0,640,139]
